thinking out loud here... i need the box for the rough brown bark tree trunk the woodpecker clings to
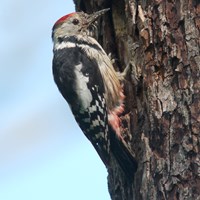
[74,0,200,200]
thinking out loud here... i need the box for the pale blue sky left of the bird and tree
[0,0,110,200]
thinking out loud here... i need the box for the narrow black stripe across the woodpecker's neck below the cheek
[58,36,102,51]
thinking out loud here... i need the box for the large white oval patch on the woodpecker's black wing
[75,64,92,109]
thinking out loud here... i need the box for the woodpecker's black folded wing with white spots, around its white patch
[53,47,110,165]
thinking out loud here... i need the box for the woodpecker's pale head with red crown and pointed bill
[52,8,109,41]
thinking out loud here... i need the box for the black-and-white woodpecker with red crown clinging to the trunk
[52,9,137,176]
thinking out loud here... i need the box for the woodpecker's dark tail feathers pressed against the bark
[110,130,137,180]
